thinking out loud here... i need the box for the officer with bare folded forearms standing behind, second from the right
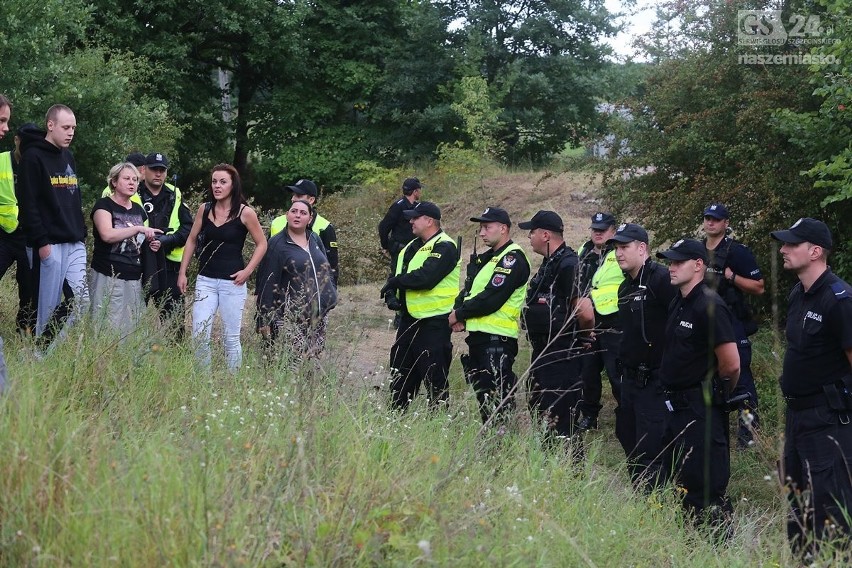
[704,203,764,448]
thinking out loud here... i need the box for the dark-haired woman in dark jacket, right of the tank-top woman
[255,200,337,356]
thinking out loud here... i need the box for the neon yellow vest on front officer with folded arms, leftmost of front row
[396,233,461,319]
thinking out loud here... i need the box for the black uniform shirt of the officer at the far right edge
[781,269,852,397]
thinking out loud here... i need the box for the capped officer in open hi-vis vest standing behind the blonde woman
[137,152,192,339]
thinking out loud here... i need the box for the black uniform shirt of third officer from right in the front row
[618,258,678,369]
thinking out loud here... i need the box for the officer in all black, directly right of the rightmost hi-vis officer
[611,223,678,488]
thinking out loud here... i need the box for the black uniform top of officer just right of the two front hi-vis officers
[521,243,579,337]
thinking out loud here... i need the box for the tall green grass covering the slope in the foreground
[0,161,844,567]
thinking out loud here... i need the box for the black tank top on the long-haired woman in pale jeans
[198,206,248,280]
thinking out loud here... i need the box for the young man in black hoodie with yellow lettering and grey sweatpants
[18,105,89,337]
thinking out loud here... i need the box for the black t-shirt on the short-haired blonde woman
[91,197,148,280]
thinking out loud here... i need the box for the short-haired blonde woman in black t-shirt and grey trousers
[89,162,162,336]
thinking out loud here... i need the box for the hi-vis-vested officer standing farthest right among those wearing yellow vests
[578,211,624,430]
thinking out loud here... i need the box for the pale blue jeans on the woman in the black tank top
[192,276,248,371]
